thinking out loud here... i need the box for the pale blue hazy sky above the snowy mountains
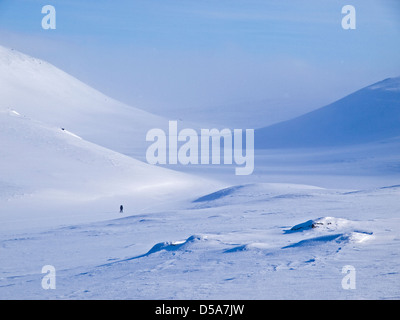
[0,0,400,125]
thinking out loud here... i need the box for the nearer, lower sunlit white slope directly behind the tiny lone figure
[0,109,220,231]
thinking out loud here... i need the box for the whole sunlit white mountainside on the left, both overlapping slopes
[0,47,220,228]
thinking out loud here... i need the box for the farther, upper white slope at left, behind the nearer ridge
[0,46,168,156]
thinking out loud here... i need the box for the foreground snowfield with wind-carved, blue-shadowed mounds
[0,185,400,299]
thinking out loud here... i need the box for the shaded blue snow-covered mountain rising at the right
[255,77,400,149]
